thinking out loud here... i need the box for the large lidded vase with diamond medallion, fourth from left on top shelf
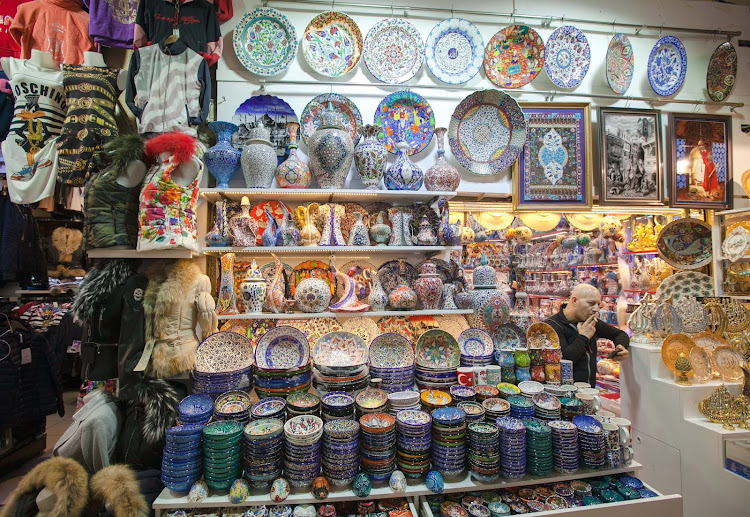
[307,106,354,189]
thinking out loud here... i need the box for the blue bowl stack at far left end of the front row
[161,424,203,492]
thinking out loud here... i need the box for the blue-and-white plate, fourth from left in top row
[424,18,484,84]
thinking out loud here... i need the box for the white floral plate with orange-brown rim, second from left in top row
[302,11,362,77]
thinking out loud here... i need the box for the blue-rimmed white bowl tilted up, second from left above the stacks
[255,326,310,370]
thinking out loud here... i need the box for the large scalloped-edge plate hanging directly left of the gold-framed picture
[448,90,526,176]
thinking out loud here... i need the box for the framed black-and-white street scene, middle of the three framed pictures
[599,108,664,206]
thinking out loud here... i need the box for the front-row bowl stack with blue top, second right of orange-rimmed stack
[432,407,467,477]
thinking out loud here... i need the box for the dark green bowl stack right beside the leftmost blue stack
[203,420,242,490]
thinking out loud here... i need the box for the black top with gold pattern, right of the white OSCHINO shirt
[57,65,120,187]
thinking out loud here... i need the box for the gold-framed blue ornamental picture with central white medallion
[513,103,593,211]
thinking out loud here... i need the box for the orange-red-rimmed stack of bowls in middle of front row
[359,413,396,481]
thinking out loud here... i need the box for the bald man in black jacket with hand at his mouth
[546,284,630,386]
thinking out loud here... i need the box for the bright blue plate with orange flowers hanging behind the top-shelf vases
[375,90,435,155]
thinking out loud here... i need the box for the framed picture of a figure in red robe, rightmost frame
[669,113,733,209]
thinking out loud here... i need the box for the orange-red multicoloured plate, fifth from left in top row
[484,25,545,88]
